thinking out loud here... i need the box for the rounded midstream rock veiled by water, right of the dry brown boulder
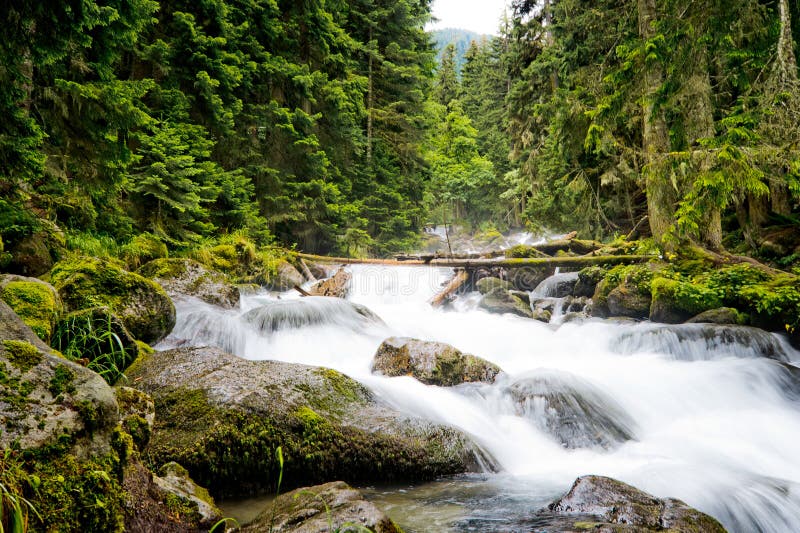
[507,371,635,449]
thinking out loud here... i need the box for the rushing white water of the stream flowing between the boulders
[165,265,800,533]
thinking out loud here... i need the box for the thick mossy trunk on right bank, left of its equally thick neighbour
[638,0,675,244]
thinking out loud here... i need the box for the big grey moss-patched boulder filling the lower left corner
[0,301,216,533]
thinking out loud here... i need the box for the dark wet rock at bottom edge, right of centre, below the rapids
[550,476,725,533]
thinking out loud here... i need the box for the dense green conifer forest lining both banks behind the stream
[0,0,800,263]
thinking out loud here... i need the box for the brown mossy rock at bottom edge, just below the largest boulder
[242,481,402,533]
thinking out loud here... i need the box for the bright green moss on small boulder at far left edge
[0,281,59,342]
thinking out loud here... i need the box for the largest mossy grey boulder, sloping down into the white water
[128,348,487,496]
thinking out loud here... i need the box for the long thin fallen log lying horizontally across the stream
[296,253,654,268]
